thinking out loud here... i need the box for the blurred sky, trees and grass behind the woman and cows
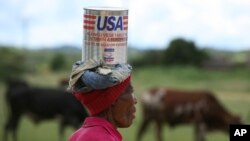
[0,0,250,141]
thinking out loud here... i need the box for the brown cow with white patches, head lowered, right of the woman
[137,88,241,141]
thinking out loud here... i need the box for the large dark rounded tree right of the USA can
[165,38,208,66]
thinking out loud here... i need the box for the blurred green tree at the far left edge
[0,46,28,80]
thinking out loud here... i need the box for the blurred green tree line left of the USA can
[0,45,81,81]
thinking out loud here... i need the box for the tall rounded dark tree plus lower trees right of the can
[129,38,209,67]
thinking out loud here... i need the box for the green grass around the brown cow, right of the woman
[120,66,250,141]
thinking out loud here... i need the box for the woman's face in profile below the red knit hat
[111,84,137,128]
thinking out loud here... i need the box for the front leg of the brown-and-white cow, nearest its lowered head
[194,122,206,141]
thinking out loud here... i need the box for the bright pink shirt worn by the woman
[69,117,122,141]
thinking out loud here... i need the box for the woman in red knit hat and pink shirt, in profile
[69,76,137,141]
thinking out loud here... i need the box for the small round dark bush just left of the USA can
[50,53,67,71]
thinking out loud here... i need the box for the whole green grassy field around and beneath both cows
[0,67,250,141]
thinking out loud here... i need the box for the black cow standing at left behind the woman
[4,80,87,141]
